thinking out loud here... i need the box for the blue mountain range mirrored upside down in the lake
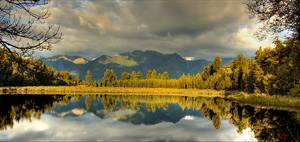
[51,97,202,125]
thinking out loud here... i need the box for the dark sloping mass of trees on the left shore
[0,49,74,86]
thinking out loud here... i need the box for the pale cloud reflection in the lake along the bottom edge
[0,113,253,141]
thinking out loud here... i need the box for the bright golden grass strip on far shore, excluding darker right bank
[0,86,225,97]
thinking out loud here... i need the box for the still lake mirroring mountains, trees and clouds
[0,95,300,141]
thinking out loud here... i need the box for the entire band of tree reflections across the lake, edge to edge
[0,95,300,141]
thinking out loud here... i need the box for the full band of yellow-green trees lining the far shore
[0,39,300,96]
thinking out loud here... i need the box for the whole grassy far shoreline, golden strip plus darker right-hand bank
[0,86,300,110]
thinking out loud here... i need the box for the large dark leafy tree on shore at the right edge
[255,39,300,94]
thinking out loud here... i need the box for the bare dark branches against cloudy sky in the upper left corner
[0,0,62,56]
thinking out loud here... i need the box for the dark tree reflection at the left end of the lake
[0,95,66,130]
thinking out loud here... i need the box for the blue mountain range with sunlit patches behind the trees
[42,50,231,79]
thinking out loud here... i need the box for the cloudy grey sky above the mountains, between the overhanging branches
[42,0,272,59]
